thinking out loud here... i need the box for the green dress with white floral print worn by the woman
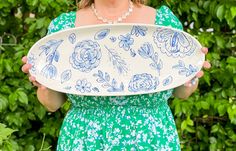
[48,6,182,151]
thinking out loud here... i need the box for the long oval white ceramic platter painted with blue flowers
[27,24,205,96]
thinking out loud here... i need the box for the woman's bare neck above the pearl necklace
[94,0,129,19]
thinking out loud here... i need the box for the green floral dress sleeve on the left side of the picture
[47,12,76,35]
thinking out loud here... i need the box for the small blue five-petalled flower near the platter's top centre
[118,34,134,51]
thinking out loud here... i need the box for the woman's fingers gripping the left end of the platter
[21,56,46,89]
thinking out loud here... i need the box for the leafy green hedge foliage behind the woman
[0,0,236,151]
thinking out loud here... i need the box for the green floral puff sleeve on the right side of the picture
[156,5,183,30]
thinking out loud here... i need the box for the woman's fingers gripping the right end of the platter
[185,47,211,86]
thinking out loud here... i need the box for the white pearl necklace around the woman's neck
[91,0,134,24]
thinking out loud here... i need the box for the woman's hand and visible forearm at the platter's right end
[173,47,211,99]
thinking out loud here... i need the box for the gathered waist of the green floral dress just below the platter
[67,90,172,108]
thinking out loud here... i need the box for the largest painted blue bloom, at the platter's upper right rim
[153,27,197,58]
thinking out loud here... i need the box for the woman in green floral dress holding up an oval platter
[22,0,210,151]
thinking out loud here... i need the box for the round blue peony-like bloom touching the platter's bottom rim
[128,73,159,92]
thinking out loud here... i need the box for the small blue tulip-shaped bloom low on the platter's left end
[41,64,57,79]
